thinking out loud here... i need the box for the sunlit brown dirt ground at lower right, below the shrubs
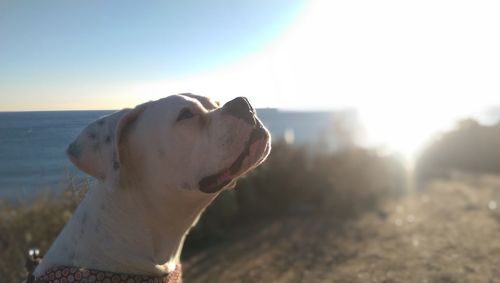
[183,176,500,283]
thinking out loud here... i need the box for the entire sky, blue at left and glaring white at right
[0,0,500,159]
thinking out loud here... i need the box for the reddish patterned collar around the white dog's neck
[34,265,182,283]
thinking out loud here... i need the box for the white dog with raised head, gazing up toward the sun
[33,94,270,282]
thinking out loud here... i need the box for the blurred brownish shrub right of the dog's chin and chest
[186,141,406,253]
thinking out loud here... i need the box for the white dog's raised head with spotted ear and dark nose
[67,94,270,199]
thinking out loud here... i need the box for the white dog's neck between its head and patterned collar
[34,185,213,277]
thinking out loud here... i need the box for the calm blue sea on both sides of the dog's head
[0,109,345,199]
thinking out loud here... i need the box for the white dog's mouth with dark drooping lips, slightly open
[198,126,270,193]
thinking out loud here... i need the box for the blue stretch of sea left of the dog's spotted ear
[0,111,112,200]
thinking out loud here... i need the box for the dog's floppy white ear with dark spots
[66,103,148,190]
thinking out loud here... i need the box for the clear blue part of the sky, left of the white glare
[0,0,304,107]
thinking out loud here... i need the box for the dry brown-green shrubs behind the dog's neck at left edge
[0,182,88,283]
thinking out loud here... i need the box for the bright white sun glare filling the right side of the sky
[2,0,500,160]
